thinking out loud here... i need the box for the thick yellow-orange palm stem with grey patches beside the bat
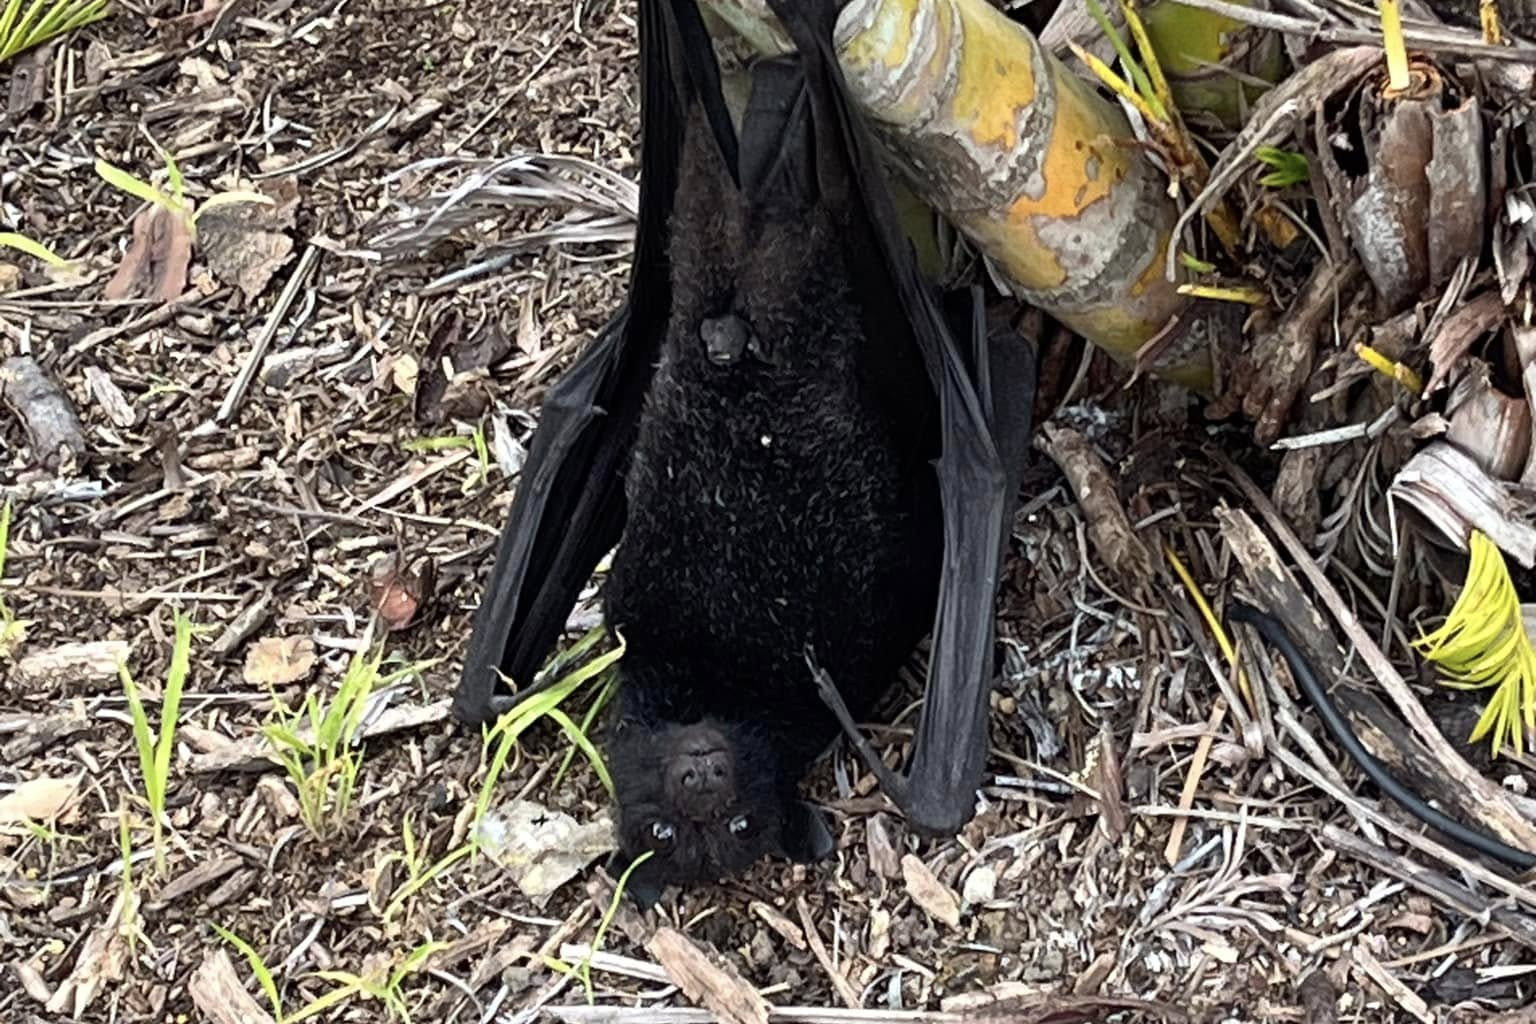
[707,0,1210,391]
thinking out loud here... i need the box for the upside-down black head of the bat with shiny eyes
[608,718,833,904]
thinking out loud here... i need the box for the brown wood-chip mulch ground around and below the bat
[0,0,1519,1024]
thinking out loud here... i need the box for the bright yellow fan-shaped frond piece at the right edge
[1415,530,1536,757]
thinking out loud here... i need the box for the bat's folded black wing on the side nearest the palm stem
[768,0,1035,834]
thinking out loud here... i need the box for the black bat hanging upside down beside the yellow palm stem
[453,0,1035,903]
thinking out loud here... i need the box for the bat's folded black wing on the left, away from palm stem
[453,0,737,725]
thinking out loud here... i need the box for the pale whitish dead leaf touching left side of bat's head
[479,800,617,907]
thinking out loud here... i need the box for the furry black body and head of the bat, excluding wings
[604,98,942,883]
